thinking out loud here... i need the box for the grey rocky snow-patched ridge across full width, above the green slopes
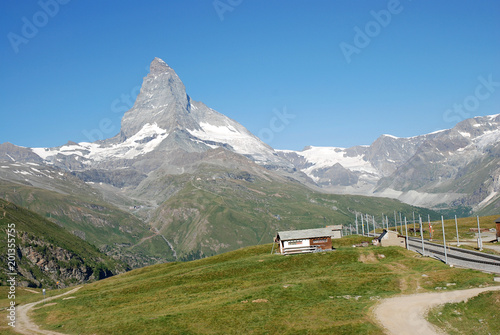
[0,57,500,215]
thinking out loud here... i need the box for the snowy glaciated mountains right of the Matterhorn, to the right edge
[279,114,500,211]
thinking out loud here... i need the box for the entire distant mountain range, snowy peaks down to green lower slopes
[0,58,500,266]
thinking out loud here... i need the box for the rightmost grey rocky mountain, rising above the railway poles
[376,115,500,211]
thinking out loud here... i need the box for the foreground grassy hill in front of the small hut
[28,237,493,334]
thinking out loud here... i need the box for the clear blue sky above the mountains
[0,0,500,150]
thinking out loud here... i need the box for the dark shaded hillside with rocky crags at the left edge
[0,199,127,288]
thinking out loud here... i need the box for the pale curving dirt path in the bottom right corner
[374,286,500,335]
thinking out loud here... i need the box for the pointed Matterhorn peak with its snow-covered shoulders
[32,58,292,172]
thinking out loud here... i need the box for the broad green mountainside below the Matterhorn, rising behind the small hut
[150,166,439,260]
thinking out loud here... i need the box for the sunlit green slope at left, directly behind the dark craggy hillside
[0,180,173,267]
